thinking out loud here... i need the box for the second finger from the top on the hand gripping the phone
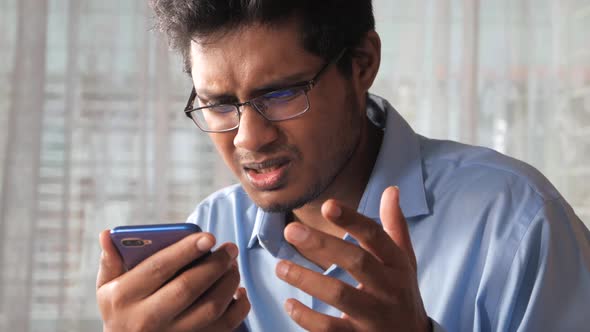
[146,243,239,317]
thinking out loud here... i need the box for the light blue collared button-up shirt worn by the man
[188,96,590,331]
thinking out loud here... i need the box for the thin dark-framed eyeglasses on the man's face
[184,49,346,133]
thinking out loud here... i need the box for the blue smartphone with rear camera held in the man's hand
[110,223,206,273]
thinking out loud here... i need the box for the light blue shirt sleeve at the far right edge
[495,198,590,331]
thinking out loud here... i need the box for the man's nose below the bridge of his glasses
[234,104,279,151]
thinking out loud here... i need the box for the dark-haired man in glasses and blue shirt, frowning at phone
[97,0,590,331]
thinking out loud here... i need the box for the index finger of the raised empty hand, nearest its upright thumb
[322,199,403,266]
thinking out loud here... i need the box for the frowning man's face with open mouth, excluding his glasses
[191,22,364,211]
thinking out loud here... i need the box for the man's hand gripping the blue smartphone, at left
[96,230,250,332]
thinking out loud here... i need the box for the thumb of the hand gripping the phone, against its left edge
[96,229,125,289]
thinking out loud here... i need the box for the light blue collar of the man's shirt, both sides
[248,95,429,252]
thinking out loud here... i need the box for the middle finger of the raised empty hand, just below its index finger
[284,222,390,290]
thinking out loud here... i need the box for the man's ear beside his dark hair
[352,30,381,94]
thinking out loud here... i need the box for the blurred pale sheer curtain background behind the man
[0,0,590,331]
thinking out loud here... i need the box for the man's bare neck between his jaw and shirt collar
[289,119,383,237]
